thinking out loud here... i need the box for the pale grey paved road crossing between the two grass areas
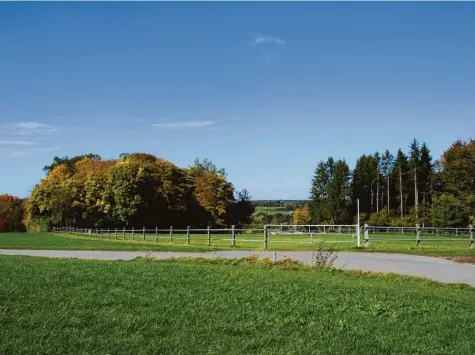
[0,249,475,287]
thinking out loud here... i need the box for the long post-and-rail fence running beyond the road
[53,224,474,248]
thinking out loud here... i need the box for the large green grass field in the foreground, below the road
[0,256,475,355]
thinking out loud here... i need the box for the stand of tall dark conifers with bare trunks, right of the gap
[309,139,475,226]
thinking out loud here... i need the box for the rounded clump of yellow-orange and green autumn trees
[18,153,254,230]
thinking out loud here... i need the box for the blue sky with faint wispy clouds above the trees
[0,2,475,199]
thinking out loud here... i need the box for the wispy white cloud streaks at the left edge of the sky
[0,121,59,157]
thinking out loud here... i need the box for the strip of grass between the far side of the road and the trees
[0,233,475,260]
